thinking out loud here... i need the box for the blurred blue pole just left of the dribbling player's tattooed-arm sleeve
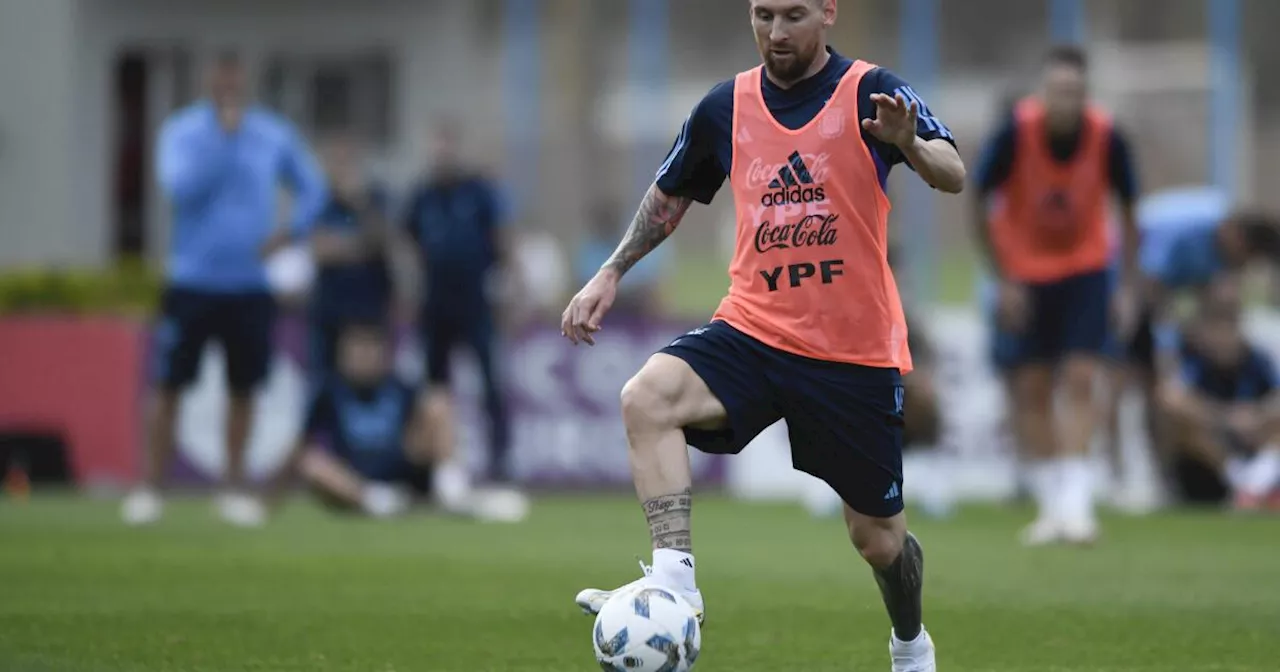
[627,0,671,202]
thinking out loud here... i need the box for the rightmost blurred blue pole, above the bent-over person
[1204,0,1243,195]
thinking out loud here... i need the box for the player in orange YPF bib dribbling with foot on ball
[561,0,964,672]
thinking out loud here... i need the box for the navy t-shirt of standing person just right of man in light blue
[312,192,392,320]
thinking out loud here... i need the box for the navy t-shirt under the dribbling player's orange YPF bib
[657,49,955,204]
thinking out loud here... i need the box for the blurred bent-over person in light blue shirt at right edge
[1124,187,1280,468]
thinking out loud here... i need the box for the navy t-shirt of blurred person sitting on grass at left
[303,376,417,480]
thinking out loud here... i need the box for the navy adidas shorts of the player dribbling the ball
[662,321,904,518]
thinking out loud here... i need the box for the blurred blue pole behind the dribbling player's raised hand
[897,0,940,301]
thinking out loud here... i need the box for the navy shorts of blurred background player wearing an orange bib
[992,270,1117,369]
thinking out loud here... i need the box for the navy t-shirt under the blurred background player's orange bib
[977,114,1138,204]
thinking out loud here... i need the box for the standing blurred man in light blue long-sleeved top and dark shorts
[122,54,325,525]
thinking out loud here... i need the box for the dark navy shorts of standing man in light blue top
[155,287,276,394]
